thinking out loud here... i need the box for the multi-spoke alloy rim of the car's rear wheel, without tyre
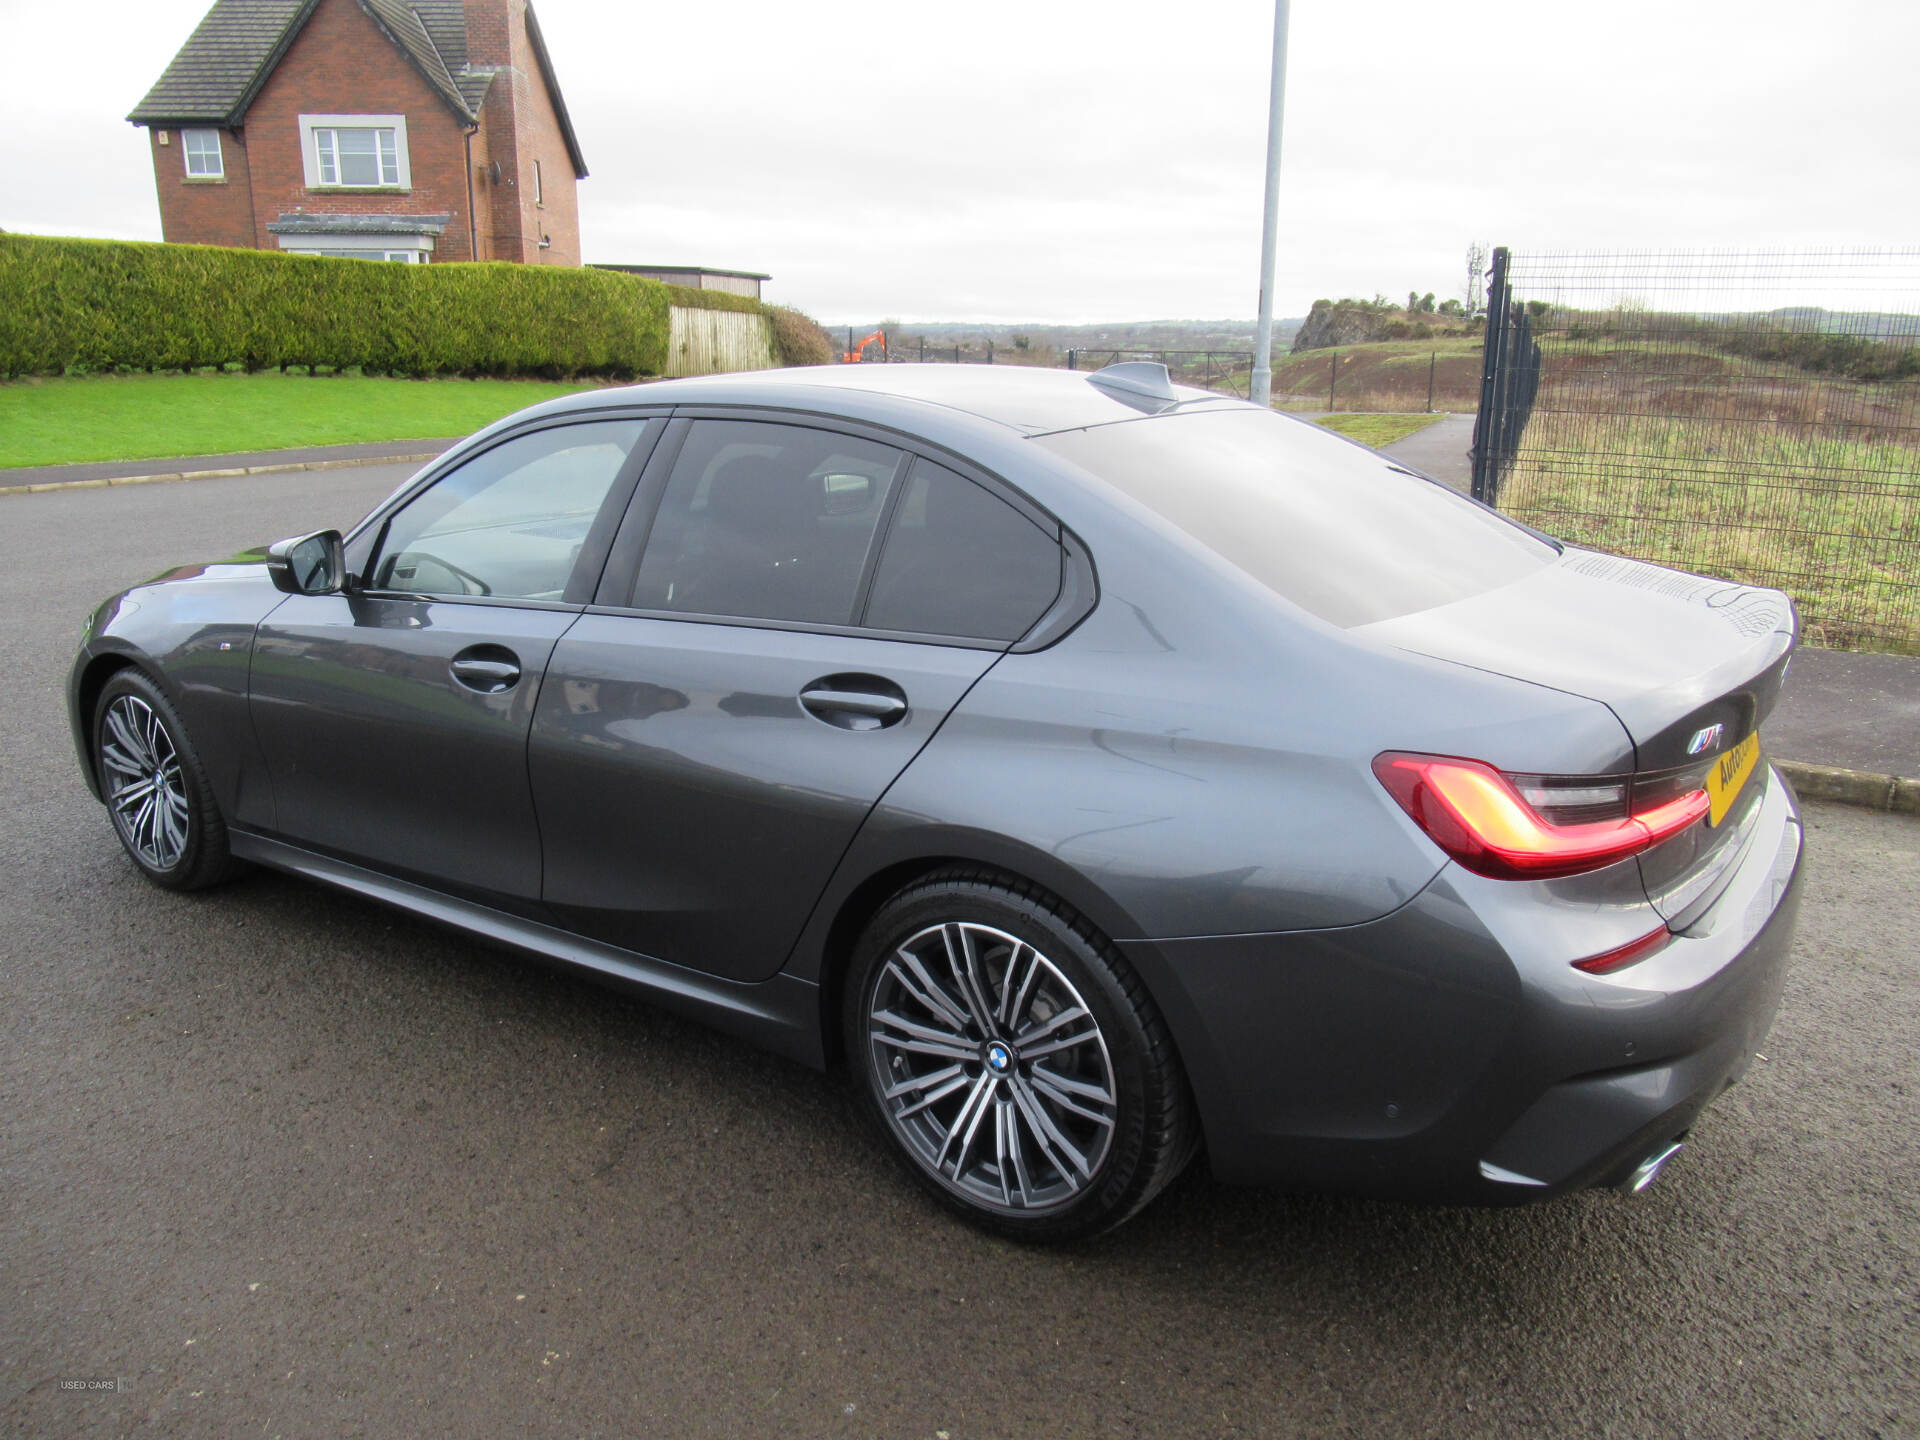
[866,922,1119,1215]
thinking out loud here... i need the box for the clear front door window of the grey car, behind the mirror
[369,420,647,601]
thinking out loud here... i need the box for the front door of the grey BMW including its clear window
[250,419,664,910]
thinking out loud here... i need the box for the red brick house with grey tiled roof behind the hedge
[127,0,588,265]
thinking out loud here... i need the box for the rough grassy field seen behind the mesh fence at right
[1500,344,1920,655]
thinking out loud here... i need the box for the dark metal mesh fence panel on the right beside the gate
[1482,250,1920,653]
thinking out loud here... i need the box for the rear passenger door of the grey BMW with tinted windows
[530,417,1062,979]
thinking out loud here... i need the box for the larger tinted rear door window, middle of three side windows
[634,420,900,626]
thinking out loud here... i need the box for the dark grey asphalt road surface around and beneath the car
[0,470,1920,1440]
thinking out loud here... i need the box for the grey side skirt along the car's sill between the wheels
[228,829,826,1069]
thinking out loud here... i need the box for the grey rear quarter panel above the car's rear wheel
[795,509,1630,973]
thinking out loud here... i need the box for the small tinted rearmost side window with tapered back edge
[866,461,1060,639]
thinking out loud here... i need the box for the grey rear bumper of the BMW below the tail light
[1121,772,1803,1204]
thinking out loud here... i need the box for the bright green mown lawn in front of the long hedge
[0,371,614,468]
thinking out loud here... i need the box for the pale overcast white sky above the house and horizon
[0,0,1920,323]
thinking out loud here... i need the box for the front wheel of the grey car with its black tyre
[94,668,236,891]
